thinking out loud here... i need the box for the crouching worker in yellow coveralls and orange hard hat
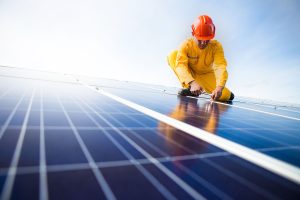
[168,15,234,101]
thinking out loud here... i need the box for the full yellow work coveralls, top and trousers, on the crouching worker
[168,38,231,101]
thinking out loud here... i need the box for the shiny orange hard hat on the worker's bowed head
[192,15,216,40]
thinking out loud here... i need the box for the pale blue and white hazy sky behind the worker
[0,0,300,103]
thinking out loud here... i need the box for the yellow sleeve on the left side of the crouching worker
[175,41,194,87]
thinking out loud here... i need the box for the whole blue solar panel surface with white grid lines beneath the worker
[0,67,300,200]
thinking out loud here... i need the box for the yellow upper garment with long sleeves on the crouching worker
[175,38,228,87]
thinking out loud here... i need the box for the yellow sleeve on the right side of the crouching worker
[213,43,228,87]
